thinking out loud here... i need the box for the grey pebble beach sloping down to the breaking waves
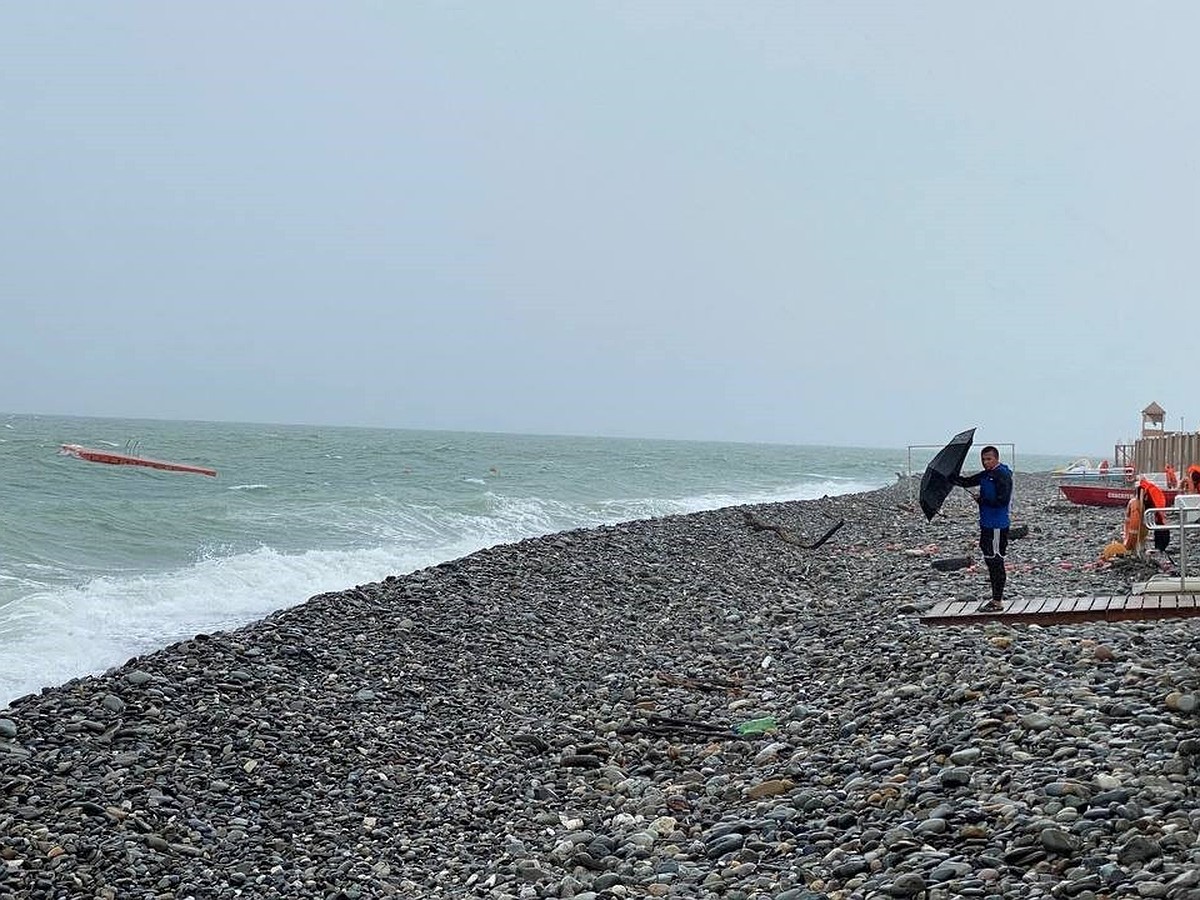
[0,473,1200,900]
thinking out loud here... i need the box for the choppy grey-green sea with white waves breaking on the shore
[0,415,1062,708]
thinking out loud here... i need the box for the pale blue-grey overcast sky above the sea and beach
[0,0,1200,454]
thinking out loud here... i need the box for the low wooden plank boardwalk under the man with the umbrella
[920,593,1200,625]
